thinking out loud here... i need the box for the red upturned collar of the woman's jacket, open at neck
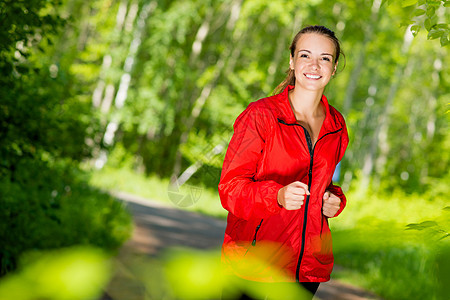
[278,85,342,138]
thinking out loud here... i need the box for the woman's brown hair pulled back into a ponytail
[273,25,344,94]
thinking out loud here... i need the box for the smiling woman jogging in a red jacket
[219,26,348,294]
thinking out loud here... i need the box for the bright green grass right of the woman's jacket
[330,188,450,299]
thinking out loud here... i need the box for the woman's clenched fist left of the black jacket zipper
[277,181,309,210]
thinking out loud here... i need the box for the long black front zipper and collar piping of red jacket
[278,119,342,282]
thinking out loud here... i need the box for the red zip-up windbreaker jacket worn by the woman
[219,86,348,282]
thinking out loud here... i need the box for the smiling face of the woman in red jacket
[290,33,337,93]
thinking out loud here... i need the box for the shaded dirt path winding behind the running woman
[102,193,380,300]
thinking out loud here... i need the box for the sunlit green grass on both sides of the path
[91,167,450,299]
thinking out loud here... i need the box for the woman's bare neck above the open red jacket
[289,87,323,117]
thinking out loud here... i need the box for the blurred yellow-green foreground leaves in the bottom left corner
[0,247,110,300]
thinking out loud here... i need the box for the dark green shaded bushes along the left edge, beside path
[0,0,131,276]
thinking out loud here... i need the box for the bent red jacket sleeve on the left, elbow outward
[219,103,283,220]
